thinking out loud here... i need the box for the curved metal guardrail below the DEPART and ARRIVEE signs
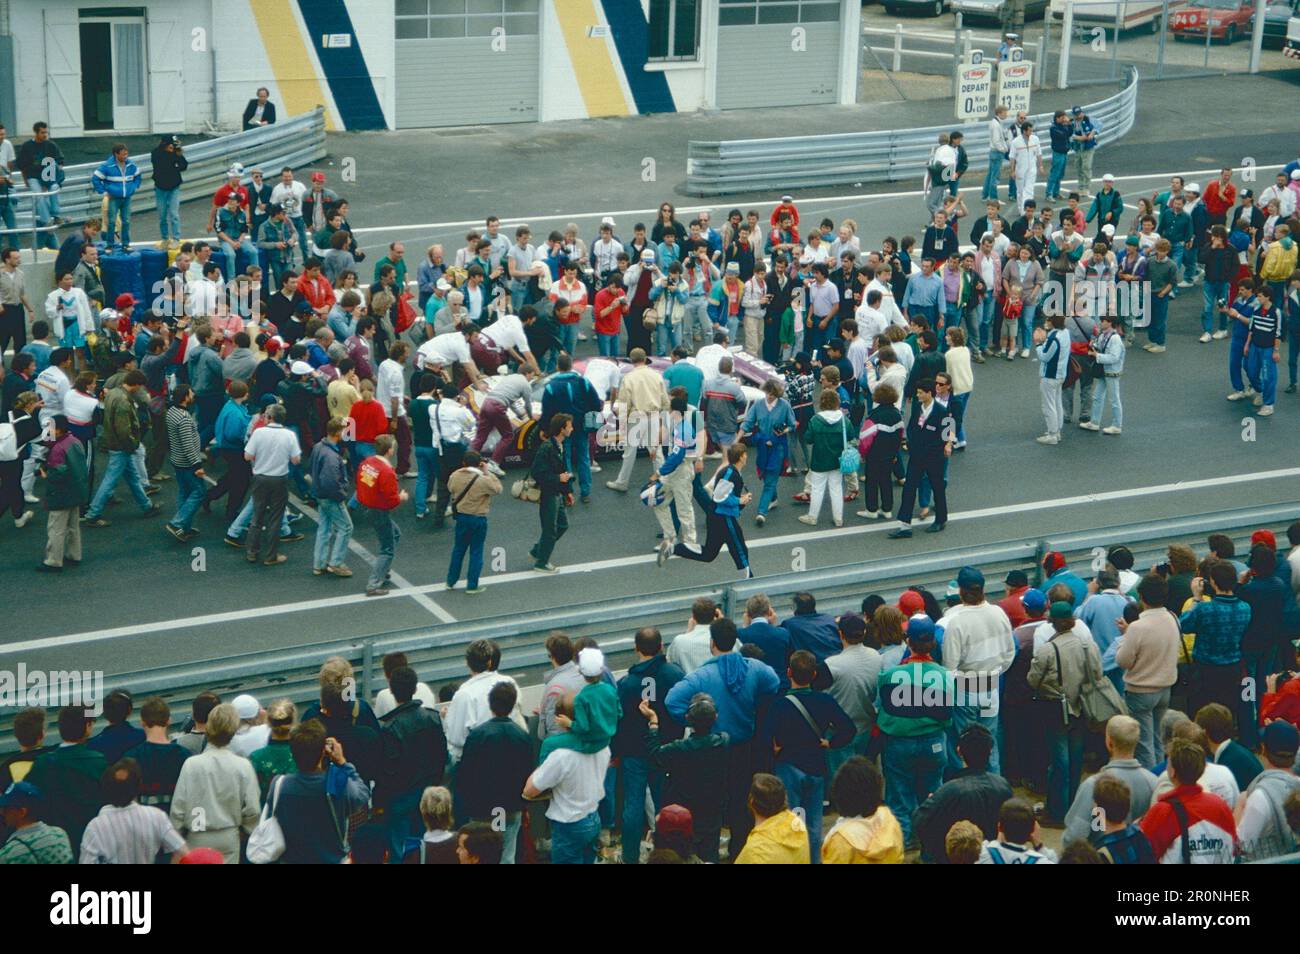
[685,66,1138,196]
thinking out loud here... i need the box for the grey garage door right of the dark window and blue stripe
[718,0,840,109]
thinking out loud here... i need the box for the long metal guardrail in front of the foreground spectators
[0,500,1300,754]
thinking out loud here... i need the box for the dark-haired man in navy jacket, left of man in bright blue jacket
[612,626,685,864]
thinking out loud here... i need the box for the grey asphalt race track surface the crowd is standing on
[0,67,1300,675]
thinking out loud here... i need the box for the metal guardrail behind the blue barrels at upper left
[10,107,325,230]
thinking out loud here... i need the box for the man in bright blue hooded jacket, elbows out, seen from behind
[664,619,780,858]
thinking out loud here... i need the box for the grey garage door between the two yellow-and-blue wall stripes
[397,0,540,129]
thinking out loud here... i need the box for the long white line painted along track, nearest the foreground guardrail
[0,467,1300,655]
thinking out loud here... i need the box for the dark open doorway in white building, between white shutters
[79,16,150,133]
